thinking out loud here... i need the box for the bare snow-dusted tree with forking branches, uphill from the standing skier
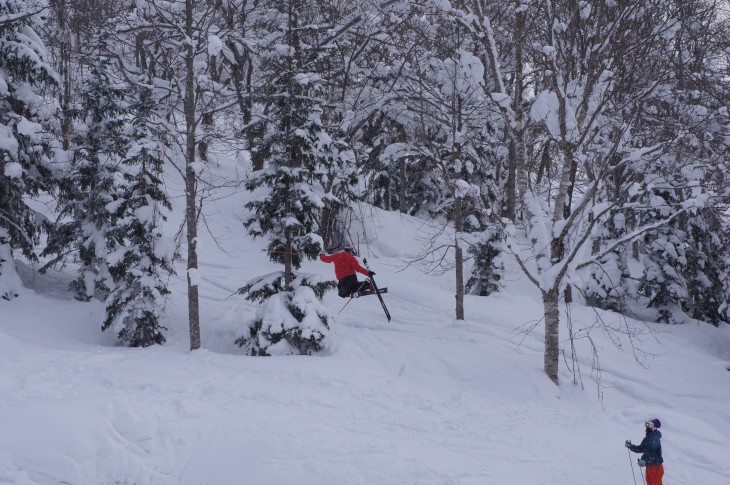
[515,0,720,383]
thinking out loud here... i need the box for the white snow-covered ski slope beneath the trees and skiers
[0,157,730,485]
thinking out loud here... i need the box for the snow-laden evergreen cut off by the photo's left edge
[0,0,56,299]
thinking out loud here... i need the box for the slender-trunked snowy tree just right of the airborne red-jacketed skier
[382,5,494,320]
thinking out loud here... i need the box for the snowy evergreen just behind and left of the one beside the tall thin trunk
[44,48,128,301]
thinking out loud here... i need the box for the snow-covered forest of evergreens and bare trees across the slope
[0,0,730,383]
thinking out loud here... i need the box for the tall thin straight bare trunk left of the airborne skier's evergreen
[185,0,200,350]
